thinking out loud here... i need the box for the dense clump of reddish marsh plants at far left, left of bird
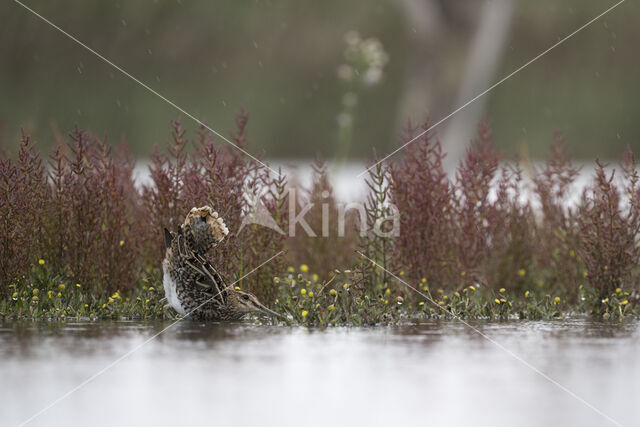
[0,128,138,289]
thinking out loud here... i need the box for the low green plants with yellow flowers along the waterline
[0,264,640,326]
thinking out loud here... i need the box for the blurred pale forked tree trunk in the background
[398,0,516,166]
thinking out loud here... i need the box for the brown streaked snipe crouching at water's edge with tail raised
[162,206,283,321]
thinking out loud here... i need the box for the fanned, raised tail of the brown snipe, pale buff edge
[182,206,229,254]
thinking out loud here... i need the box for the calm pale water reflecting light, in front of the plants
[0,319,640,426]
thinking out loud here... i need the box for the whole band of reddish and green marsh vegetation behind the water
[0,113,640,325]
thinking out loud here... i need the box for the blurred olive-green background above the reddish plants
[0,0,640,160]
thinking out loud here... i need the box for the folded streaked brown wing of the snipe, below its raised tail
[176,227,228,305]
